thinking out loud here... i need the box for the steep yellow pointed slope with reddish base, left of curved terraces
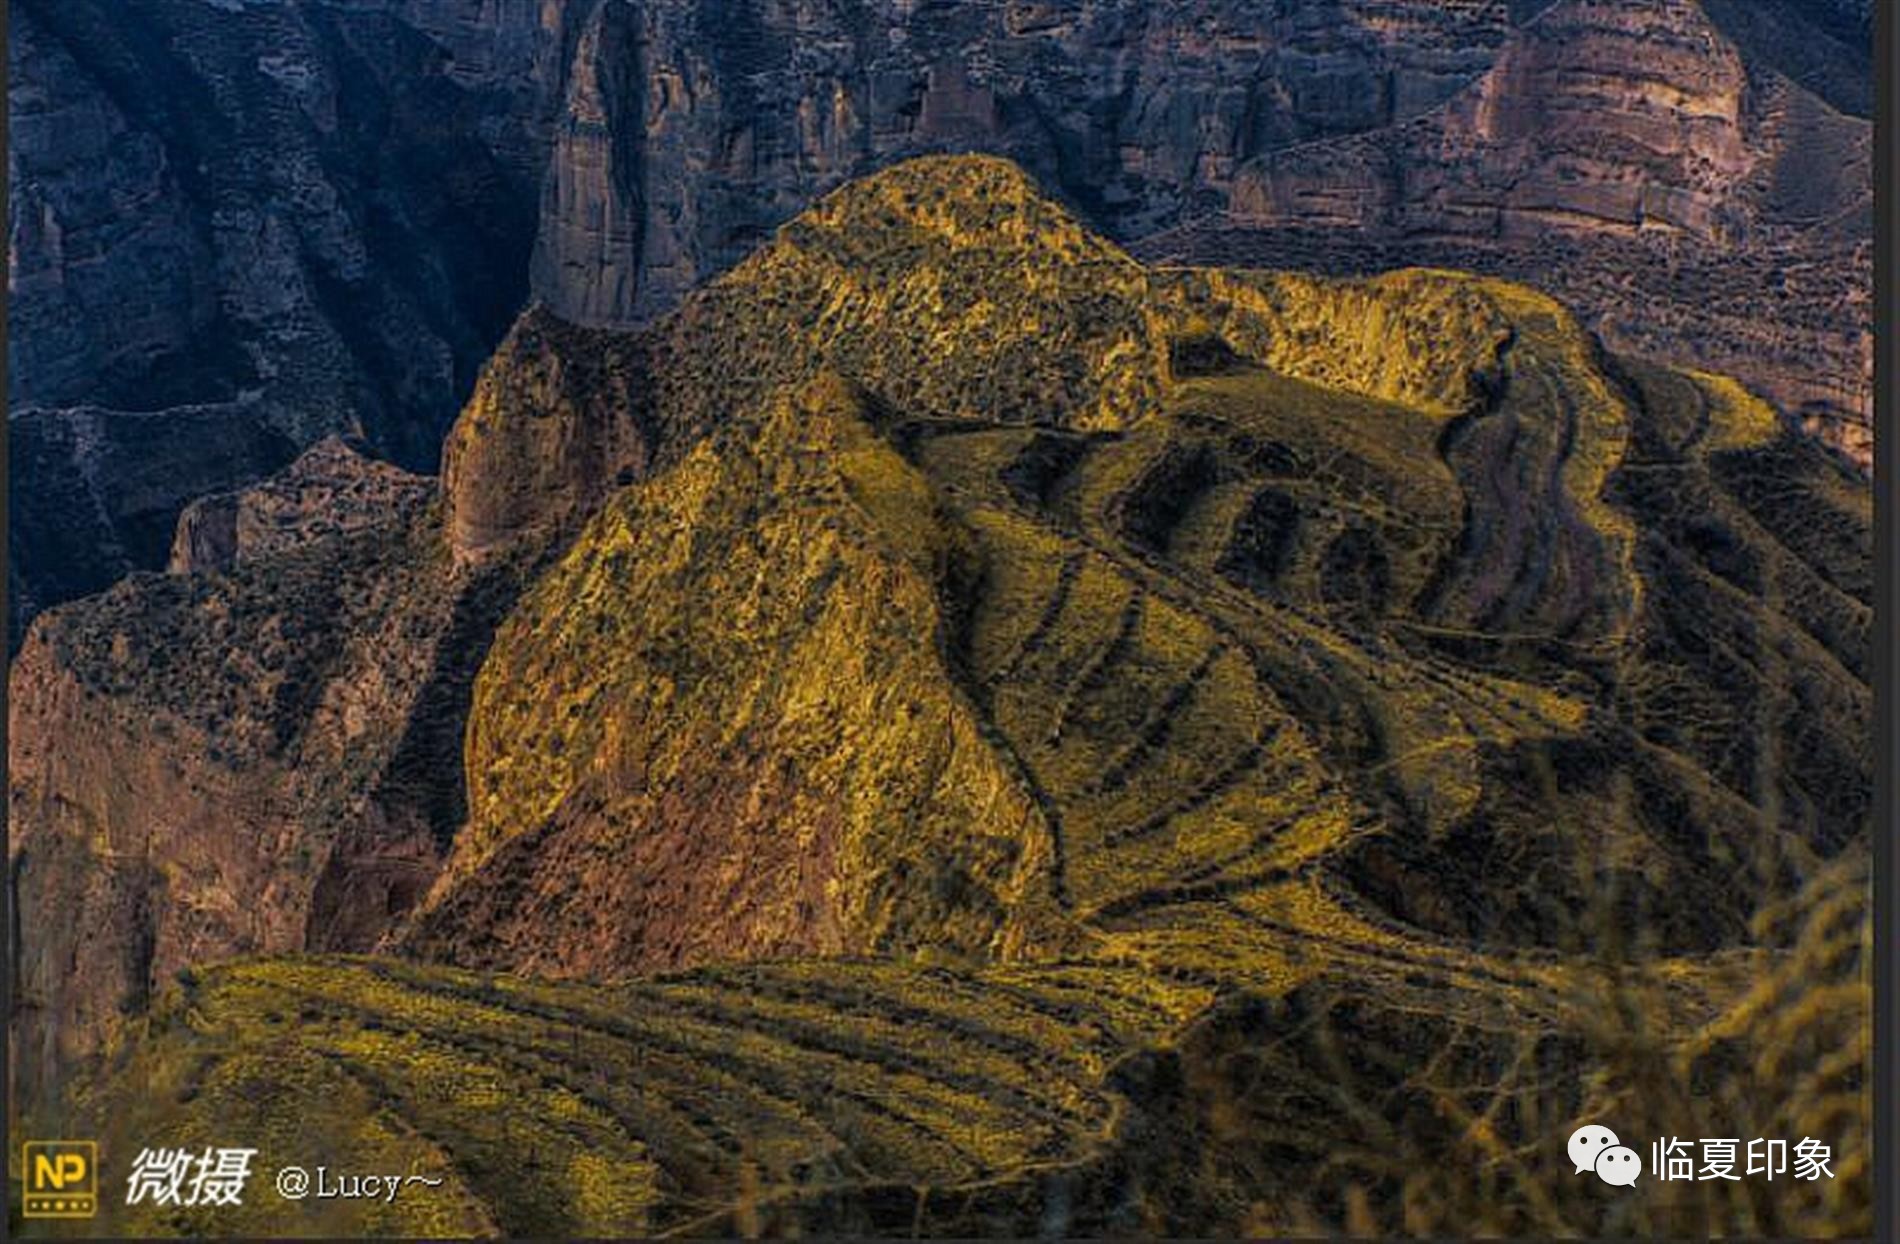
[405,384,1053,976]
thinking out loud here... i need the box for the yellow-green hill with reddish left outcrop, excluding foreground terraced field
[10,156,1873,1162]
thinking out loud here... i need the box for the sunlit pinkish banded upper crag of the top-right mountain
[1233,2,1752,241]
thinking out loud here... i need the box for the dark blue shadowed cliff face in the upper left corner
[8,0,559,651]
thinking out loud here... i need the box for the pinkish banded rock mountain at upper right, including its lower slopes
[1142,0,1873,465]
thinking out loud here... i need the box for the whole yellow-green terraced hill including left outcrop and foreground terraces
[10,156,1873,1235]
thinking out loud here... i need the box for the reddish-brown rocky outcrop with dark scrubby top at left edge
[8,482,505,1092]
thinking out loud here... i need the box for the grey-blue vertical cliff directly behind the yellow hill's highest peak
[536,0,1509,327]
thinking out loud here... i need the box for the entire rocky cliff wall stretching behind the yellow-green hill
[8,0,1872,650]
